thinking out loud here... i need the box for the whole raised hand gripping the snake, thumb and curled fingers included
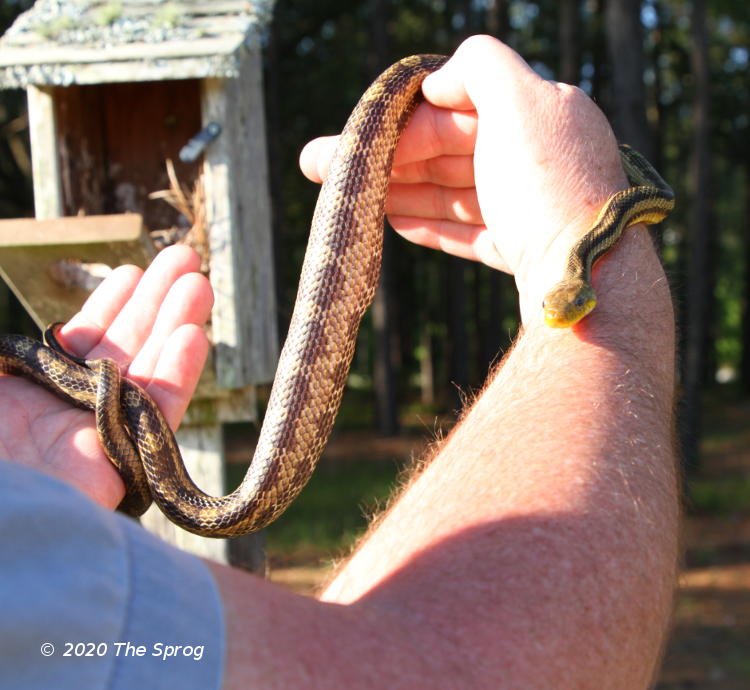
[300,36,627,323]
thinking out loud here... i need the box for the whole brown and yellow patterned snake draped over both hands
[0,55,668,537]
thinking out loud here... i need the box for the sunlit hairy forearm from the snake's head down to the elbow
[325,224,677,688]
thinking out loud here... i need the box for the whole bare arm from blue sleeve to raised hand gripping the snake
[216,37,677,690]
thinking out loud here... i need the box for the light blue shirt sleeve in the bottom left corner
[0,461,224,690]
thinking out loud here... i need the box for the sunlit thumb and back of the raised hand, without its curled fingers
[423,36,627,292]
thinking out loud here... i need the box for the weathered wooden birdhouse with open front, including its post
[0,0,277,562]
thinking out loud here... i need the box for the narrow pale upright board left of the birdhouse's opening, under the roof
[26,86,62,218]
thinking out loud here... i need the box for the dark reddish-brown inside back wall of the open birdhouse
[54,79,201,230]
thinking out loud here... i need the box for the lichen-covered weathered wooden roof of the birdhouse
[0,0,273,88]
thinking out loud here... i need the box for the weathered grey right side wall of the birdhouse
[203,51,278,388]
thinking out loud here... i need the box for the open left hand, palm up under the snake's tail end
[0,246,213,509]
